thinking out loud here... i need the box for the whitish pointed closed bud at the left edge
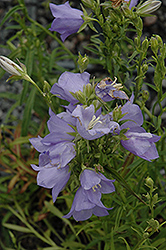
[0,56,23,76]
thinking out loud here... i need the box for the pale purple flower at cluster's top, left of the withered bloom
[51,72,90,104]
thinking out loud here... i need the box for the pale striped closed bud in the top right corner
[136,0,161,15]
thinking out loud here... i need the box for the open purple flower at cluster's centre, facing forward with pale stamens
[72,104,119,140]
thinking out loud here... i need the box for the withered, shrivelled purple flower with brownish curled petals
[95,77,129,102]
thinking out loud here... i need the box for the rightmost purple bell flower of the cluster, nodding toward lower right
[121,121,161,161]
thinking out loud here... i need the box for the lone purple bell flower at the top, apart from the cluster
[50,1,84,42]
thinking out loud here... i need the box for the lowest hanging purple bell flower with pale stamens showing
[64,169,115,221]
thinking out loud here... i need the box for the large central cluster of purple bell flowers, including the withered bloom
[30,72,160,221]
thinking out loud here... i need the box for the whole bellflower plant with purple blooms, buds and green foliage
[0,0,166,250]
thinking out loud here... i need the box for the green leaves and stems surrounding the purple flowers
[0,0,166,250]
